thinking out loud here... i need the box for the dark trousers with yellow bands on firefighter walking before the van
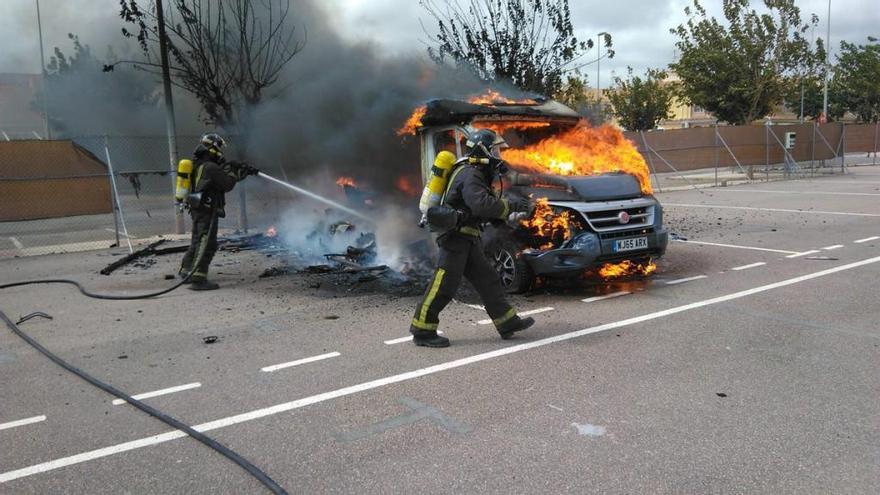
[410,232,516,335]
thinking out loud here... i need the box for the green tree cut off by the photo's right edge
[829,37,880,122]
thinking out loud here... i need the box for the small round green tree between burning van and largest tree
[605,67,675,131]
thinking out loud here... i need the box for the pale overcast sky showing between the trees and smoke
[0,0,880,86]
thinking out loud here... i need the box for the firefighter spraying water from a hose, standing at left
[179,133,259,290]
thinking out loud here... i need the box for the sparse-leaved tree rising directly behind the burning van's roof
[420,0,614,95]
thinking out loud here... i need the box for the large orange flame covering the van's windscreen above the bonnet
[501,123,653,194]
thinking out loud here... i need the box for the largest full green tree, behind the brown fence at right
[670,0,824,124]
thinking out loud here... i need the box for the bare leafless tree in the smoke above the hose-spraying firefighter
[113,0,305,132]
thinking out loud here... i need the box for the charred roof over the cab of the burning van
[422,100,581,126]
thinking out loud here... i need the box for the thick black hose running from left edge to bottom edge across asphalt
[0,310,287,495]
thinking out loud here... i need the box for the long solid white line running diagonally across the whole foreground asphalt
[0,256,880,483]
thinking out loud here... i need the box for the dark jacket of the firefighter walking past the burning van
[445,164,510,236]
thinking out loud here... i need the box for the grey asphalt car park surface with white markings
[0,167,880,494]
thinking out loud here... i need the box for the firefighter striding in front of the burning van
[410,129,535,347]
